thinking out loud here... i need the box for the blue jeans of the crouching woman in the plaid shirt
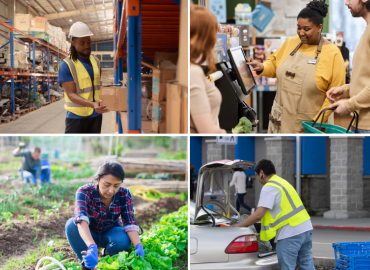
[66,218,131,262]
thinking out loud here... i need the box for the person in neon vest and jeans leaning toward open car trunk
[232,159,315,270]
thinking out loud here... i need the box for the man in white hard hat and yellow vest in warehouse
[59,22,109,133]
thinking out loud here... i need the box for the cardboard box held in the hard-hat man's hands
[100,86,127,112]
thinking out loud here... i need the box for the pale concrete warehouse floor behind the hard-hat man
[0,99,111,135]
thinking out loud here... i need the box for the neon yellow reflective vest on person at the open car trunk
[260,175,310,241]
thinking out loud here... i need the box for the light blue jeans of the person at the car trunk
[276,231,315,270]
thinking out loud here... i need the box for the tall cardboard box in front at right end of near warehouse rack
[166,82,188,133]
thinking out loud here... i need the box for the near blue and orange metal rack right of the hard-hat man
[114,0,180,133]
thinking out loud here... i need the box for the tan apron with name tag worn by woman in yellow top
[268,37,333,133]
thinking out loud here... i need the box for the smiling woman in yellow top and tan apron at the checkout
[248,0,346,133]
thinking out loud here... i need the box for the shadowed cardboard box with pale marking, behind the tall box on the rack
[152,69,176,101]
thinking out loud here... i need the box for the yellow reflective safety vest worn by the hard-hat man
[63,55,100,117]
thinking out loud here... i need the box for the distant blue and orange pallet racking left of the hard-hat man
[0,18,68,113]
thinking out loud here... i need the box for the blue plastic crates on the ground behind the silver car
[333,242,370,270]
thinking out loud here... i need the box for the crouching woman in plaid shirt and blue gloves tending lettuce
[66,161,144,269]
